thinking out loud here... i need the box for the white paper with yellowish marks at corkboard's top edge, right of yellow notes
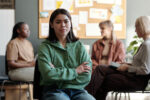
[75,0,93,7]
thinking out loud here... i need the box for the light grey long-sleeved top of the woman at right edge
[128,38,150,75]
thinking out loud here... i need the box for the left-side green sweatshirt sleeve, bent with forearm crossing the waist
[38,44,78,84]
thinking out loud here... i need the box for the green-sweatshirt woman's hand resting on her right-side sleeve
[76,62,91,74]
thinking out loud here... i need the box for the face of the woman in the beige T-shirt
[17,24,30,38]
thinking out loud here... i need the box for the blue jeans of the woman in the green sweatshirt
[42,87,95,100]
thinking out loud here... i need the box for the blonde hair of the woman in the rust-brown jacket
[99,20,117,43]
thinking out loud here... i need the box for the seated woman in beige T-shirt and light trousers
[6,22,35,81]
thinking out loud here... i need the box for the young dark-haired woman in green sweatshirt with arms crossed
[38,9,95,100]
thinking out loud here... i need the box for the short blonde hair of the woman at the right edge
[135,16,150,35]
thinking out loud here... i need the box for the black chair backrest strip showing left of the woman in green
[33,60,42,100]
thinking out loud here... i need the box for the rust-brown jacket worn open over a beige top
[91,39,125,70]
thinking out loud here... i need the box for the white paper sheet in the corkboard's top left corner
[43,0,56,10]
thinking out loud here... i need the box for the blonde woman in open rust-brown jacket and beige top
[91,20,125,71]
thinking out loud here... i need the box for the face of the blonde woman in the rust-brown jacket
[100,25,112,38]
